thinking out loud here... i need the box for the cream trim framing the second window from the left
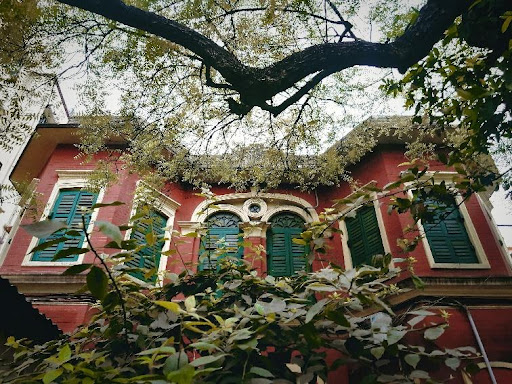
[124,180,181,287]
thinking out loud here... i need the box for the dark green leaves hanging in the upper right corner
[383,0,512,186]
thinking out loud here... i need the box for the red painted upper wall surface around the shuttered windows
[0,145,512,340]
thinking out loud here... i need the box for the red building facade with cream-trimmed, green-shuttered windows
[0,118,512,383]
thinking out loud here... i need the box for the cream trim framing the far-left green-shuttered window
[21,170,105,267]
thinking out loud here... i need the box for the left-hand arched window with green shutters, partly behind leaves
[199,212,244,270]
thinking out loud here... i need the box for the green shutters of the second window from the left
[125,211,167,283]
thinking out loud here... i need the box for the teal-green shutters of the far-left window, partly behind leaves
[31,190,98,261]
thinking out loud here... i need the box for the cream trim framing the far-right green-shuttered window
[407,172,491,269]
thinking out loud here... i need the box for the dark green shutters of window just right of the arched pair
[345,206,384,267]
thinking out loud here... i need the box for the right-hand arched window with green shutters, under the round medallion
[267,212,306,277]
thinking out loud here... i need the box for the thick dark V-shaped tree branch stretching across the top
[58,0,472,114]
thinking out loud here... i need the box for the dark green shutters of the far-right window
[423,200,478,264]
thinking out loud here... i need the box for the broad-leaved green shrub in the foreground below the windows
[0,190,486,383]
